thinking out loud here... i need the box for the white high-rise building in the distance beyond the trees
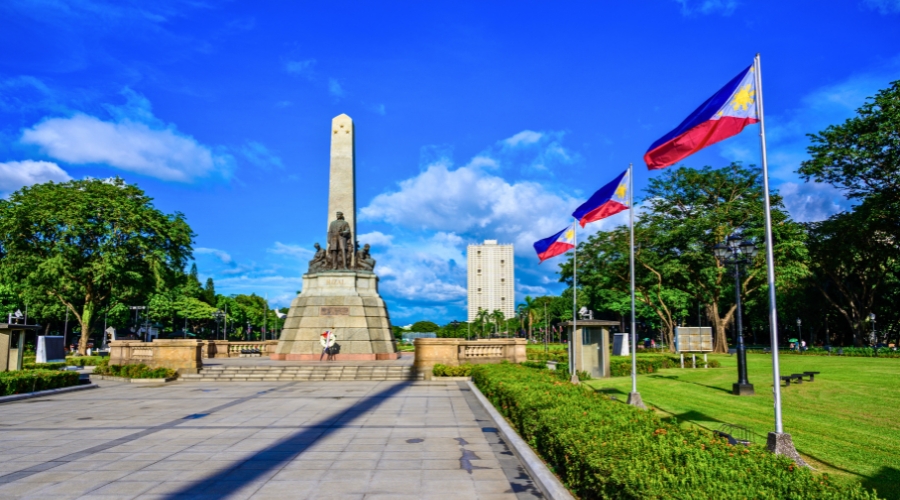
[468,240,516,321]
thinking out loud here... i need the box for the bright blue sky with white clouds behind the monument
[0,0,900,324]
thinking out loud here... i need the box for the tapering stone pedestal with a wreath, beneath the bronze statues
[271,271,400,361]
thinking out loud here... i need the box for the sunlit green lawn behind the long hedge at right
[587,354,900,500]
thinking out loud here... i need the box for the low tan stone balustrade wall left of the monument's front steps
[109,339,203,374]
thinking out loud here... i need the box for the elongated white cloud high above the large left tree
[20,90,233,182]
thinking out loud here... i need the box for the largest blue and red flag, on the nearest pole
[644,66,759,170]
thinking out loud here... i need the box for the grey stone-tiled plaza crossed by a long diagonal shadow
[0,381,541,499]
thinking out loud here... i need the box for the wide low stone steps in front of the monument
[178,366,424,382]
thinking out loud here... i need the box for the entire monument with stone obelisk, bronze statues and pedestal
[272,114,399,361]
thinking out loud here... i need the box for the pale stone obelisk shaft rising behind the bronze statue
[326,114,356,264]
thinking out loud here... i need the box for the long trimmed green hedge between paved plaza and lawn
[472,364,876,499]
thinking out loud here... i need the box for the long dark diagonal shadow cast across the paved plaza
[167,382,411,499]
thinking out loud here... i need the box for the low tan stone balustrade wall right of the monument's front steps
[413,339,528,380]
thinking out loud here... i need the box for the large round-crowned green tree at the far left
[0,178,193,353]
